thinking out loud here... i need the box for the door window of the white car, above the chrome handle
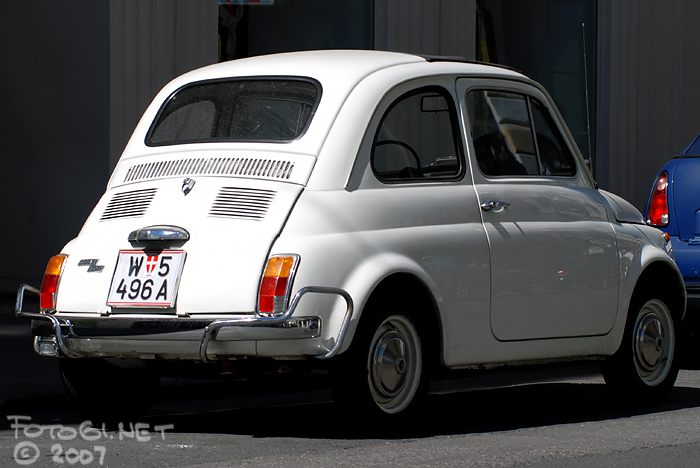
[467,90,576,176]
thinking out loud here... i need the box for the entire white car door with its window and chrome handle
[458,79,618,341]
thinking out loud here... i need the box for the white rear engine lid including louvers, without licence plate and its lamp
[57,176,303,315]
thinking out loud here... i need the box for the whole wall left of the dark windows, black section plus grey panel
[0,0,218,292]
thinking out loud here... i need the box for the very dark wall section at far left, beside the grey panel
[0,0,109,291]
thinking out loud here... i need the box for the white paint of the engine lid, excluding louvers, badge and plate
[58,176,301,314]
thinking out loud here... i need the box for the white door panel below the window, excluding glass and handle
[475,181,618,340]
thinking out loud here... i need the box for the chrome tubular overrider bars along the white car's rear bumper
[15,284,354,362]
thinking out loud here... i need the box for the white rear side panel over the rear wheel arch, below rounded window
[274,183,491,364]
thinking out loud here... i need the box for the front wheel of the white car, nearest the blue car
[602,295,678,404]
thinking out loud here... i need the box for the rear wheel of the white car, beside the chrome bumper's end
[331,297,431,417]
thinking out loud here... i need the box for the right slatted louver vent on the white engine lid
[209,187,276,221]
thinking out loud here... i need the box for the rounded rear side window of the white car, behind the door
[372,87,462,182]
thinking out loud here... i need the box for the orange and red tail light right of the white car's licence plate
[258,255,299,316]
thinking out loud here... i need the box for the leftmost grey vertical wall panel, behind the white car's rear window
[109,0,218,171]
